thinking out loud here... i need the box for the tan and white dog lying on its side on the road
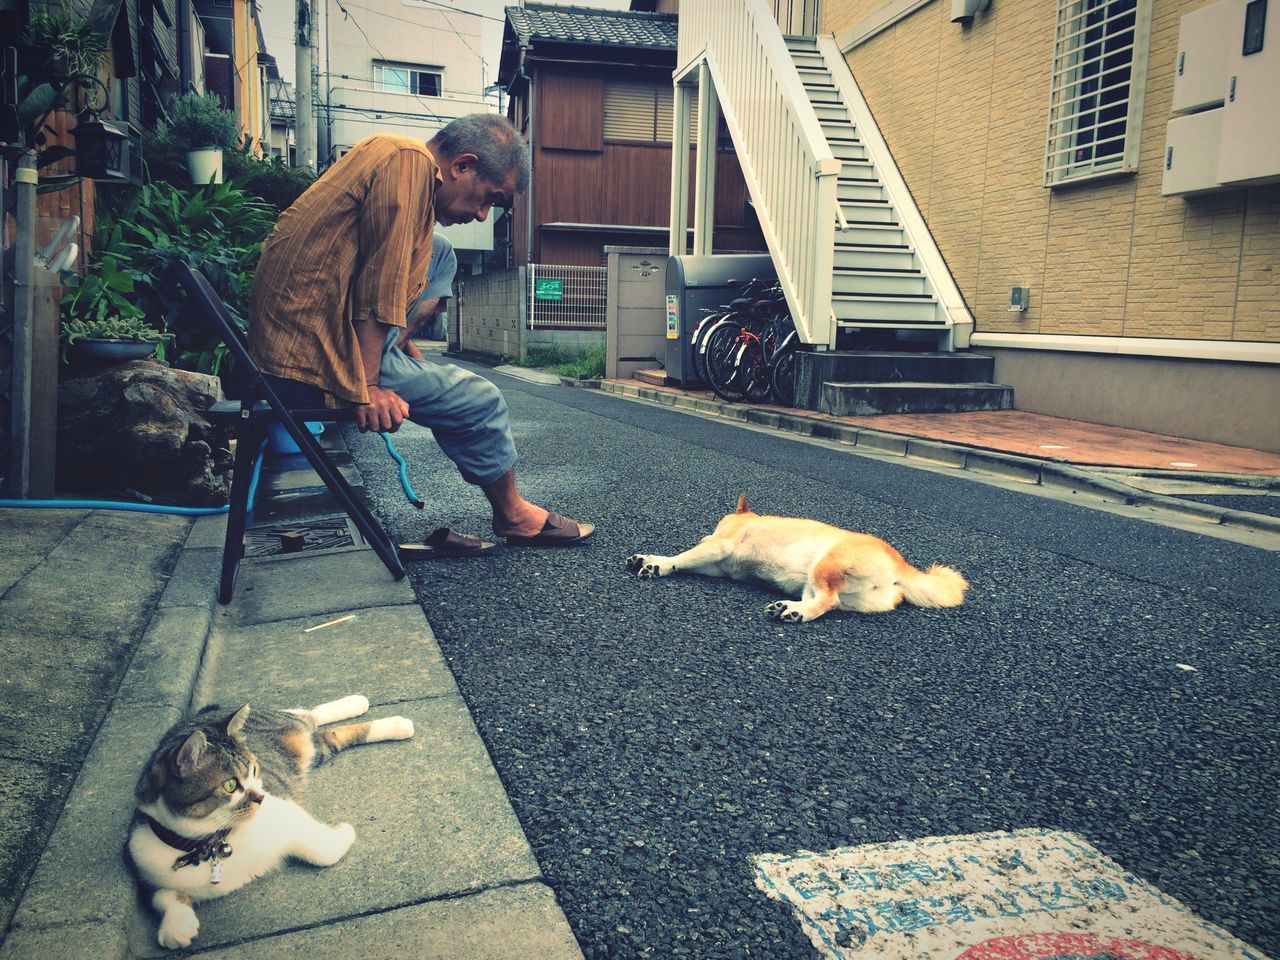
[626,494,969,623]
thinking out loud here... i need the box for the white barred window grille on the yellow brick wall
[1044,0,1151,187]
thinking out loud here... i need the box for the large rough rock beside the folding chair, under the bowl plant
[58,360,230,507]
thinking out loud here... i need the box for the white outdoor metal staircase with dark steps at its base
[671,0,1012,415]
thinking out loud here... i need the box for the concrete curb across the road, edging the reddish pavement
[600,380,1280,534]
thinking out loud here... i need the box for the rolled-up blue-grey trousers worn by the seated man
[268,328,516,486]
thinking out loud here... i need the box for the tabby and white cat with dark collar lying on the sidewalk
[128,695,413,948]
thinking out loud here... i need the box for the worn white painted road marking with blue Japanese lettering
[750,829,1266,960]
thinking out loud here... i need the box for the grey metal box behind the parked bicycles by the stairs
[667,253,777,387]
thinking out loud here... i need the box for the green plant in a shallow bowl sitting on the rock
[59,256,174,362]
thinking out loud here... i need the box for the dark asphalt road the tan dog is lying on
[348,363,1280,960]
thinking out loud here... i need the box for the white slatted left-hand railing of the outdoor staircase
[676,0,841,347]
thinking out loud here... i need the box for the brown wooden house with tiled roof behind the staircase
[499,3,764,266]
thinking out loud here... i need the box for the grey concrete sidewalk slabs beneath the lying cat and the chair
[0,440,581,960]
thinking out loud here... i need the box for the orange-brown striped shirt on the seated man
[248,134,442,403]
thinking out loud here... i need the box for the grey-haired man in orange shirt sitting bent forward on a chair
[248,114,594,547]
